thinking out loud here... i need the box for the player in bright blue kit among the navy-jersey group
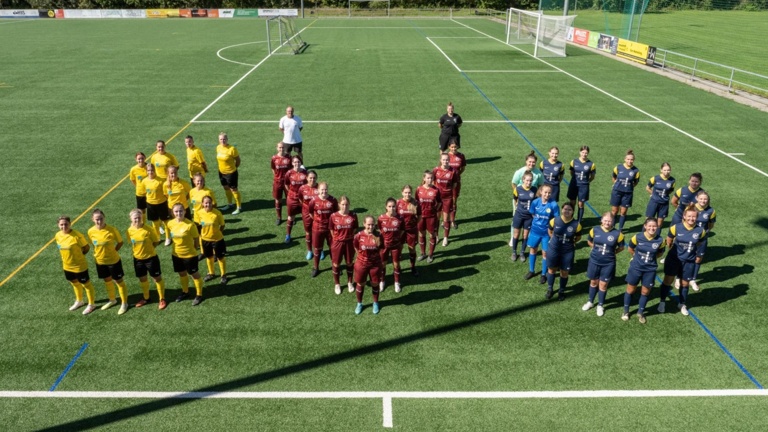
[525,184,560,284]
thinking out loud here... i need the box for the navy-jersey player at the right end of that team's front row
[659,204,707,316]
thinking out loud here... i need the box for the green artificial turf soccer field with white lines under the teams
[0,19,768,431]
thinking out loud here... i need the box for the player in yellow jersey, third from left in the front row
[128,207,168,310]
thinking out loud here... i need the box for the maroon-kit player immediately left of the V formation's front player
[329,195,359,294]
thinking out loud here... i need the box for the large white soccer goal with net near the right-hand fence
[507,8,576,57]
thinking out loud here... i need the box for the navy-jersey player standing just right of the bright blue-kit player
[545,203,581,301]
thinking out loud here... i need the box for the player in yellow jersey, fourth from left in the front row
[168,204,203,306]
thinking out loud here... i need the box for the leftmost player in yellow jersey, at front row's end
[55,216,96,315]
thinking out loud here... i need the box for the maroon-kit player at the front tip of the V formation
[352,216,383,315]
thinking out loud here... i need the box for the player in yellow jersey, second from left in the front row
[88,209,128,315]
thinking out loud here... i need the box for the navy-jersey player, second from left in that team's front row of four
[581,212,624,316]
